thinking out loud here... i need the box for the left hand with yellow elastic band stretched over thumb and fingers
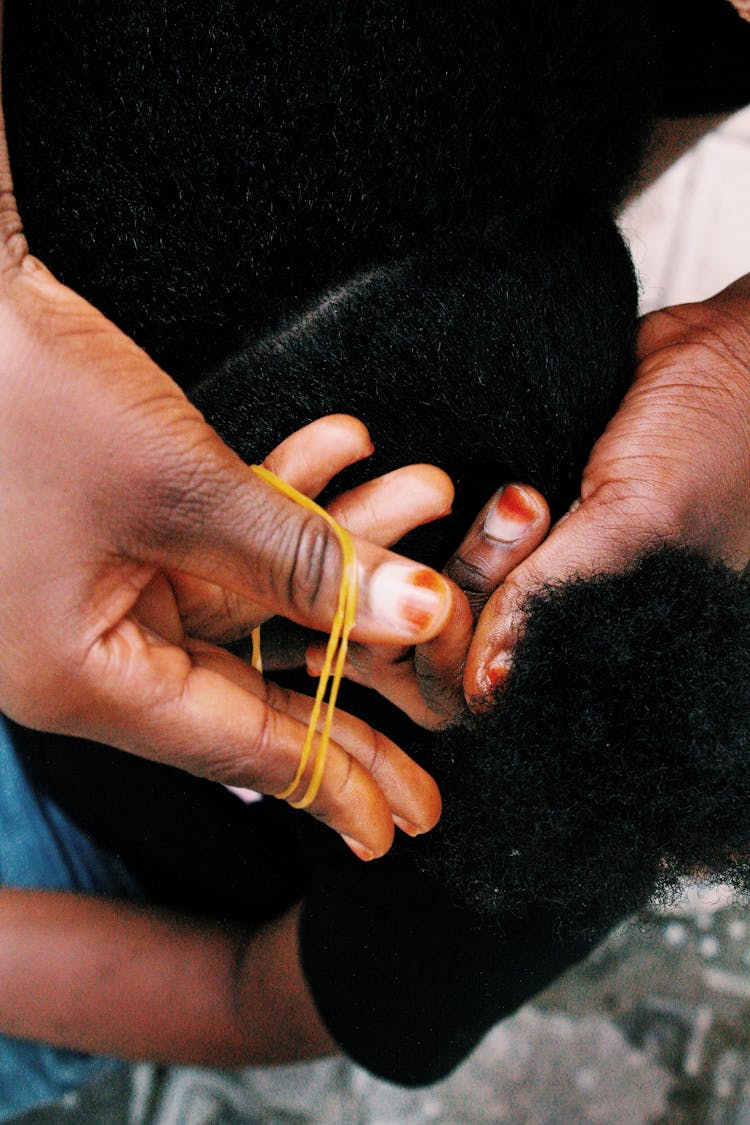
[0,207,452,855]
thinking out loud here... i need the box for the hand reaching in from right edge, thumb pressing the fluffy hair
[463,275,750,710]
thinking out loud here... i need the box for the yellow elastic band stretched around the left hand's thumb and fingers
[251,465,358,809]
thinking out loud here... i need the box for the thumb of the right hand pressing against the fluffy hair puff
[463,489,660,712]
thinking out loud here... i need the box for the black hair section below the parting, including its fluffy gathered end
[197,218,750,926]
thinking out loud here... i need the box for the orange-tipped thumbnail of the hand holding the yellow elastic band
[370,563,451,636]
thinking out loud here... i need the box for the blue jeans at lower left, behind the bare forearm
[0,716,141,1122]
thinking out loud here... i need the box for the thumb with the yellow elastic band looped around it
[128,419,452,644]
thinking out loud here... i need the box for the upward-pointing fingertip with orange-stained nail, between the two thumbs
[444,484,550,617]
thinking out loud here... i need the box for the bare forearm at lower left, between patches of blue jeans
[0,889,336,1067]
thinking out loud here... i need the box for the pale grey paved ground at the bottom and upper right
[13,109,750,1125]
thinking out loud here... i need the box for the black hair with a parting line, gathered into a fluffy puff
[3,0,750,921]
